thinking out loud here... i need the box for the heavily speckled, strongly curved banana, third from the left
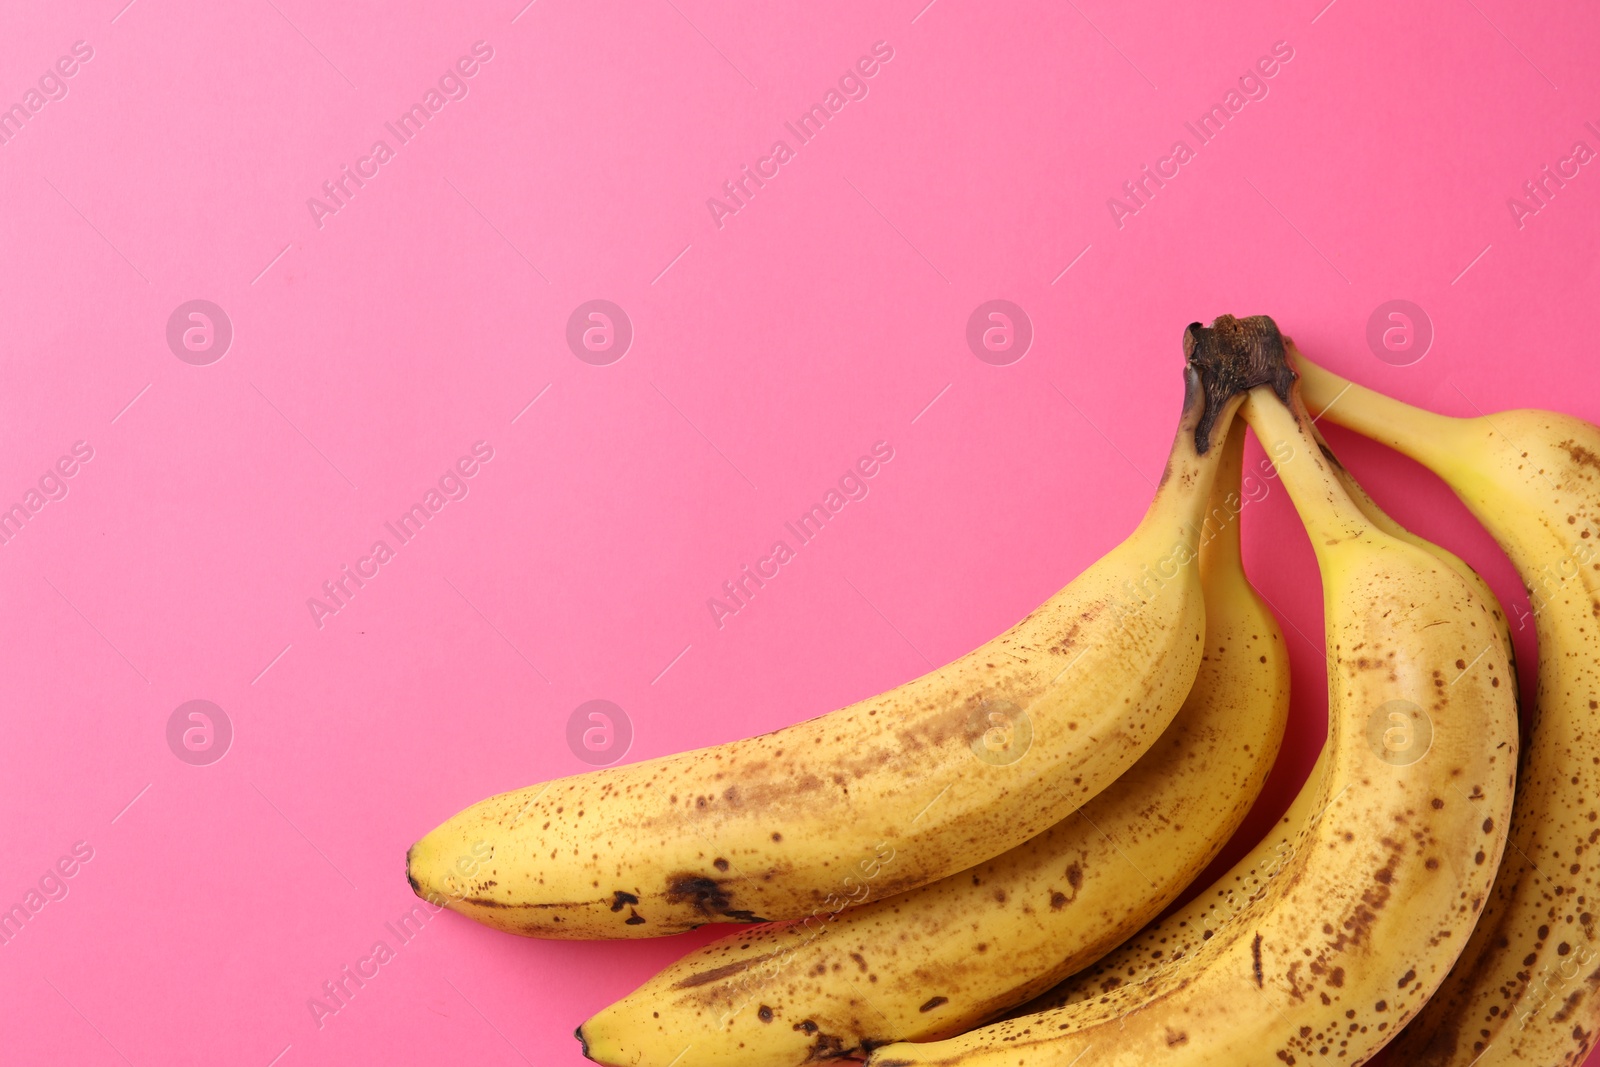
[867,321,1517,1067]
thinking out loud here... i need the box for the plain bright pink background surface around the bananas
[0,0,1600,1067]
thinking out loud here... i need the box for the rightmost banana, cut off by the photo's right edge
[1293,352,1600,1067]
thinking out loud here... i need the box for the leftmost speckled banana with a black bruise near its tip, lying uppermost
[406,334,1238,937]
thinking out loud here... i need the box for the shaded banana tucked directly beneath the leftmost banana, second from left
[578,421,1290,1067]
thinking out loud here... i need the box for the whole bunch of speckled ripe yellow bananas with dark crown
[406,315,1600,1067]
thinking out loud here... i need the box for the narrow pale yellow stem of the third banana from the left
[1243,386,1371,563]
